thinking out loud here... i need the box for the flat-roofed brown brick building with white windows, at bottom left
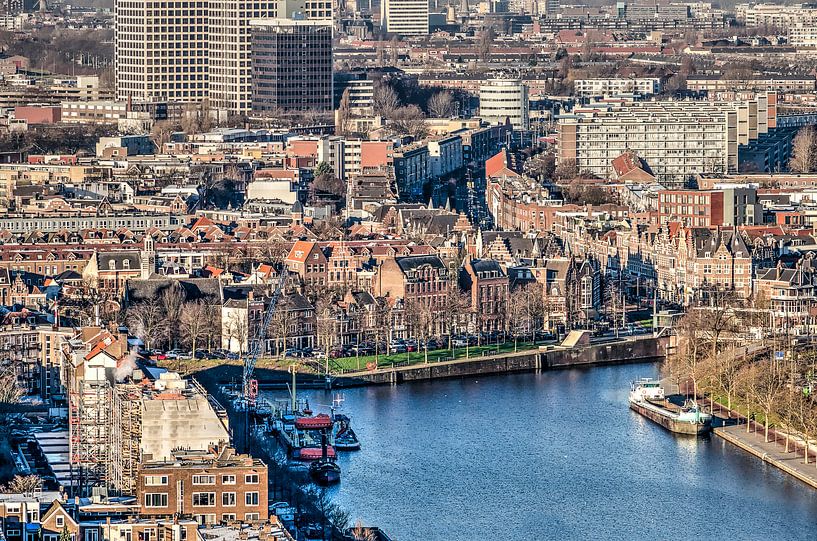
[138,447,269,524]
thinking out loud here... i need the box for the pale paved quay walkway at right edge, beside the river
[714,424,817,488]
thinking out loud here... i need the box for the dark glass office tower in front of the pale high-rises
[251,19,332,113]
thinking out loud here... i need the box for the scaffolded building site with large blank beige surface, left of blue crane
[58,328,230,496]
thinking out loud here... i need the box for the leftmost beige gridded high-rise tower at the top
[114,0,209,102]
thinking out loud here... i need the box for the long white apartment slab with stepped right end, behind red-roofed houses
[558,94,776,182]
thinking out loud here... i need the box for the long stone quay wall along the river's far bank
[344,337,669,384]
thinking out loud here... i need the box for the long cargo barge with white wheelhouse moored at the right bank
[629,378,712,435]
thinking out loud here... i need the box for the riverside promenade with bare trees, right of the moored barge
[710,396,817,488]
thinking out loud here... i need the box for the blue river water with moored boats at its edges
[260,364,817,541]
